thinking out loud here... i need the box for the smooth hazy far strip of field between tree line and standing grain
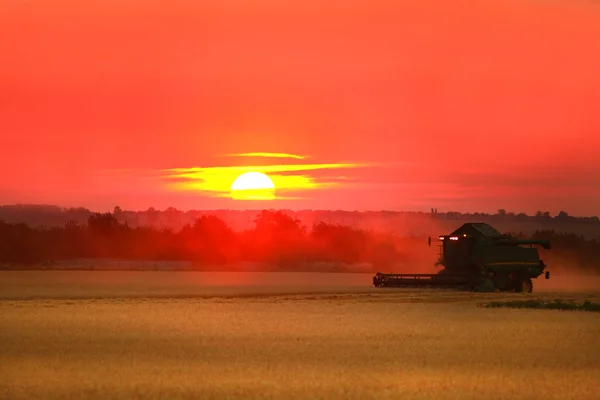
[0,270,600,301]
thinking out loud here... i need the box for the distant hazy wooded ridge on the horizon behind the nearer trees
[0,204,600,231]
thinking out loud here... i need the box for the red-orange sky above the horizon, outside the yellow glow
[0,0,600,215]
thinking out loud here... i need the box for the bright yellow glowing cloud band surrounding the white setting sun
[161,162,369,200]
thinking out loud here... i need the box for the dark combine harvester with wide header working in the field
[373,223,550,293]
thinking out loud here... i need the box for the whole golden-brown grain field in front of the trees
[0,271,600,400]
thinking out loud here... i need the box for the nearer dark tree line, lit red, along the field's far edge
[0,210,600,273]
